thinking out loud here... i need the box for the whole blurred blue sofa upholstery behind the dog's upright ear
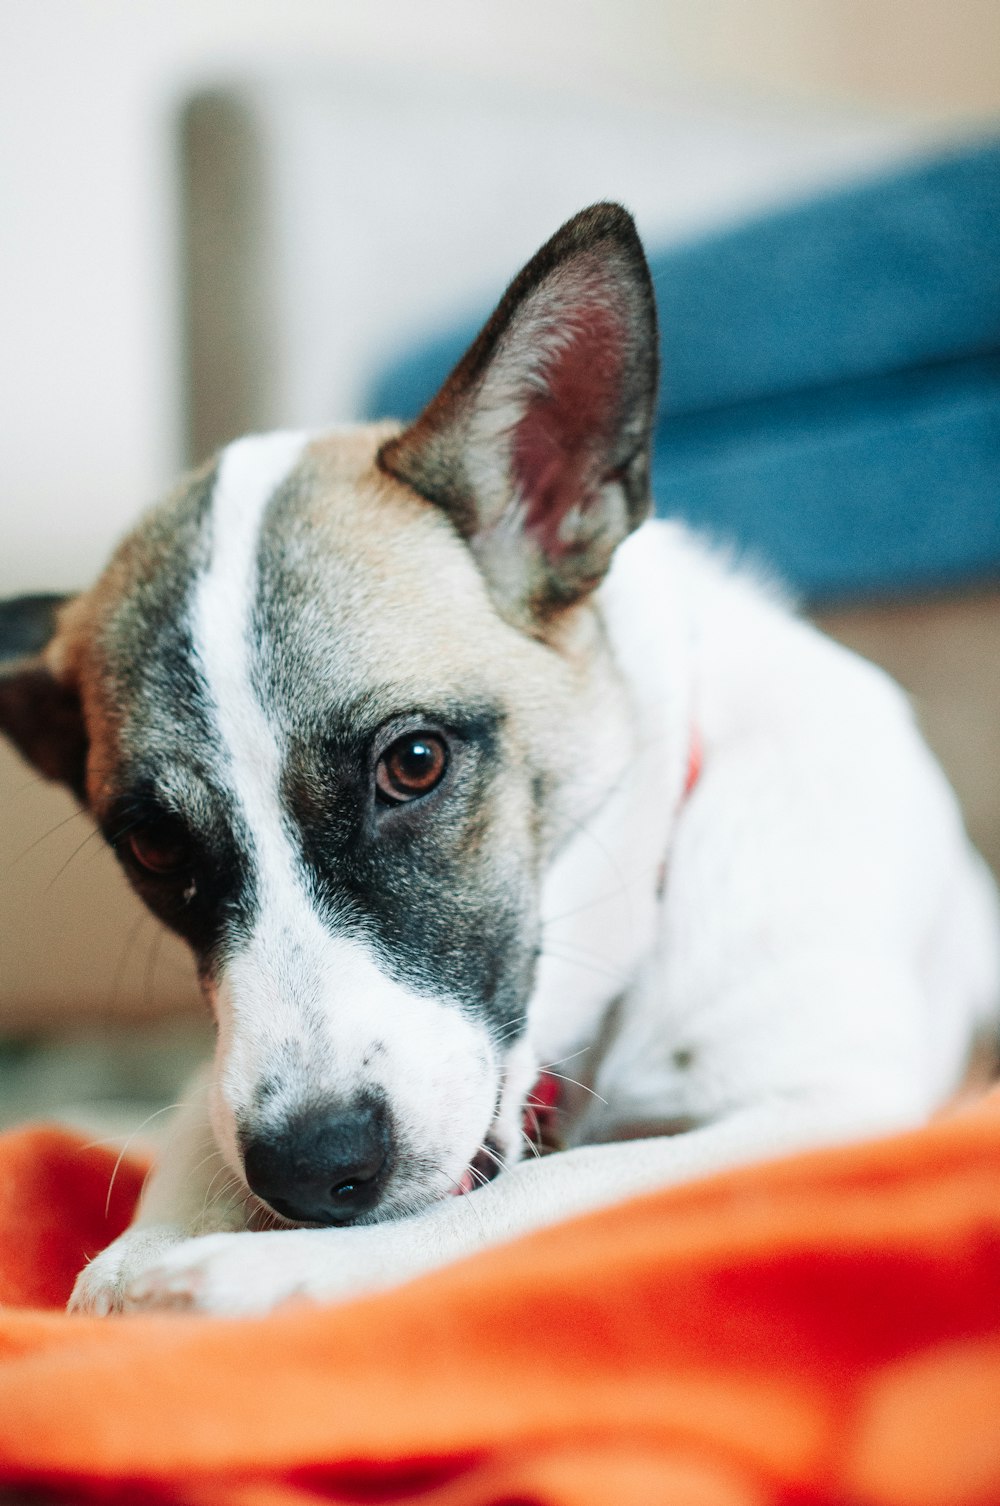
[369,143,1000,601]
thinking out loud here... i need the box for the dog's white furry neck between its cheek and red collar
[529,524,696,1065]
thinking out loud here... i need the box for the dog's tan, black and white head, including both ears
[0,205,657,1223]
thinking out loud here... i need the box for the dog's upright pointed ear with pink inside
[380,203,658,625]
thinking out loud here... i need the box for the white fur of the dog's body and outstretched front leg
[66,512,1000,1312]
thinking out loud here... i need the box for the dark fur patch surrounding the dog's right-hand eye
[283,706,533,1033]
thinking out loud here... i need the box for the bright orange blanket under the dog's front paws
[0,1096,1000,1506]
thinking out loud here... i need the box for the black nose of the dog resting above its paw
[242,1104,390,1224]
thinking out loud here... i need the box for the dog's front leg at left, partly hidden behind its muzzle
[69,1071,247,1315]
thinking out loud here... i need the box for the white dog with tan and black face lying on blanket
[0,205,1000,1313]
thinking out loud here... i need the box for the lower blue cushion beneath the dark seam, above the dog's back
[654,355,1000,602]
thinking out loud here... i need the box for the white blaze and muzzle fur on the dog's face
[185,434,500,1211]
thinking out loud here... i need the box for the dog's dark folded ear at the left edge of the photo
[0,596,87,800]
